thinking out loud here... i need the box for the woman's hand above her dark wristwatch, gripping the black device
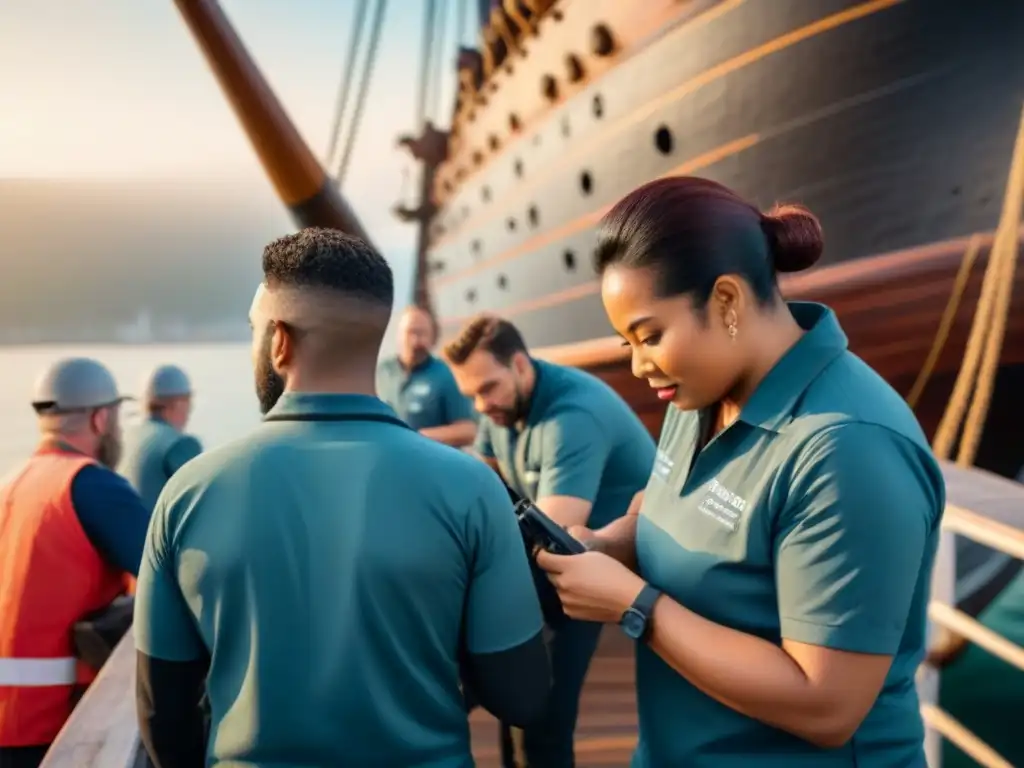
[537,551,644,624]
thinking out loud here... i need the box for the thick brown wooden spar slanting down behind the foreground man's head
[175,0,369,242]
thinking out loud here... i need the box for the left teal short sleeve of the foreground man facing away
[133,494,207,662]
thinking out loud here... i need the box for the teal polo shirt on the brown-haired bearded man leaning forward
[475,360,654,528]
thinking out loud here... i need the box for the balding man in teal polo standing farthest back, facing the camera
[377,306,476,447]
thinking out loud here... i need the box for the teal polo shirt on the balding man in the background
[377,355,475,429]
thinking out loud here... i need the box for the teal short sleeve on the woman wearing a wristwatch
[775,424,944,655]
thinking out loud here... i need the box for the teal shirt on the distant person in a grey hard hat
[118,416,203,512]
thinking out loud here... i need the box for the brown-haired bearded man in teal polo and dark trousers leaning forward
[444,314,654,766]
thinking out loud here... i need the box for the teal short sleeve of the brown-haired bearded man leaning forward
[537,411,608,504]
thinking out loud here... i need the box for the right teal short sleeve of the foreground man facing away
[466,472,544,654]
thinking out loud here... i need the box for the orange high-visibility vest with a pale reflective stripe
[0,446,125,746]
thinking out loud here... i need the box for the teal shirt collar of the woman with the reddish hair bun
[739,301,848,431]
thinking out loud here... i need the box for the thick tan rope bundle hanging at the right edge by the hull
[932,100,1024,466]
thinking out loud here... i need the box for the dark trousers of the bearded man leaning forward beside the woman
[499,618,603,768]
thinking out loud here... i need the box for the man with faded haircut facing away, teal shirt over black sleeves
[135,228,550,768]
